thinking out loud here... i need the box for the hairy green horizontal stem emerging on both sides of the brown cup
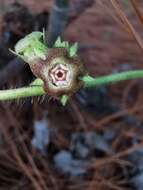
[0,70,143,100]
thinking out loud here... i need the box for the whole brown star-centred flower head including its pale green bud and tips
[11,31,85,105]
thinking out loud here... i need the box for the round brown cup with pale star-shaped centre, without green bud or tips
[30,48,83,97]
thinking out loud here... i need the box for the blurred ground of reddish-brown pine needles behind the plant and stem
[0,0,143,190]
